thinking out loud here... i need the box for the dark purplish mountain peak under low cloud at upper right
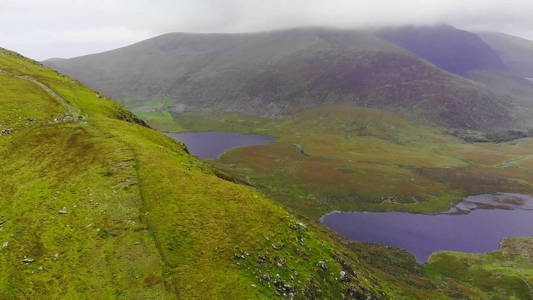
[379,25,506,75]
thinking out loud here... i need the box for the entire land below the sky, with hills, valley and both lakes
[0,25,533,299]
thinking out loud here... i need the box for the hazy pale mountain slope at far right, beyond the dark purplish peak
[478,32,533,78]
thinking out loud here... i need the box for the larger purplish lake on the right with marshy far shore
[321,193,533,263]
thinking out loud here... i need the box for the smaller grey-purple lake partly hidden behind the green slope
[165,131,277,159]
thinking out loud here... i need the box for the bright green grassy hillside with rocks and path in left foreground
[0,49,387,299]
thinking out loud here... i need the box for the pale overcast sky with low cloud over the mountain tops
[0,0,533,60]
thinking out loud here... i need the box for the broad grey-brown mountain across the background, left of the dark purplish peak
[44,28,520,131]
